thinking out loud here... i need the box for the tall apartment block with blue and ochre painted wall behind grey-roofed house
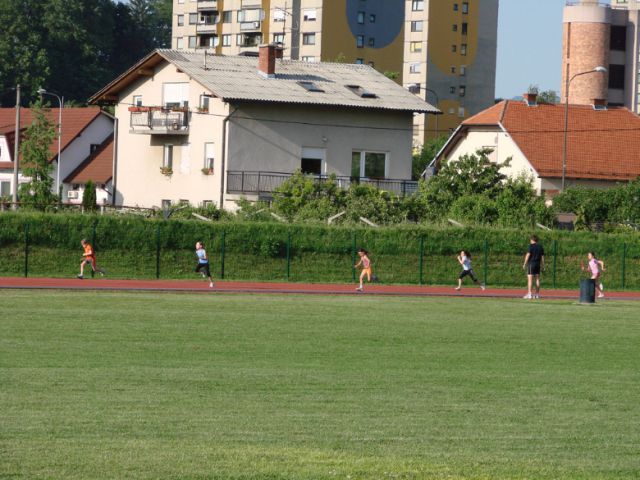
[172,0,499,145]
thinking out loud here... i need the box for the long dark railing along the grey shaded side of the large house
[227,171,418,196]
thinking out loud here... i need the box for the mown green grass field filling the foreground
[0,291,640,480]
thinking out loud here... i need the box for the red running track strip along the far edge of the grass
[0,277,640,300]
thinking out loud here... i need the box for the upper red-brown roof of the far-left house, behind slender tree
[0,107,101,161]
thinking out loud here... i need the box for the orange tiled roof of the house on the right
[463,100,640,180]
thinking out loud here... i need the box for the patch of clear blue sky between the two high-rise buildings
[496,0,567,98]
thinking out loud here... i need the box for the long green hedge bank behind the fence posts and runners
[0,213,640,289]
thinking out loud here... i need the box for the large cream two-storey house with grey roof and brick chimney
[90,45,437,209]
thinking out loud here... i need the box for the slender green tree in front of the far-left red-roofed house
[20,103,56,210]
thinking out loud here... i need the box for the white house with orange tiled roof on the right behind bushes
[434,100,640,197]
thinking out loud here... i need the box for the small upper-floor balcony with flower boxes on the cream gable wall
[129,106,189,135]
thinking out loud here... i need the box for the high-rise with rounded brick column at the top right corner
[561,0,640,113]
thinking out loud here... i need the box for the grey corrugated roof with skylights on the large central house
[156,50,439,113]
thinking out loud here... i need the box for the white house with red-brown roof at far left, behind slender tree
[0,107,113,202]
